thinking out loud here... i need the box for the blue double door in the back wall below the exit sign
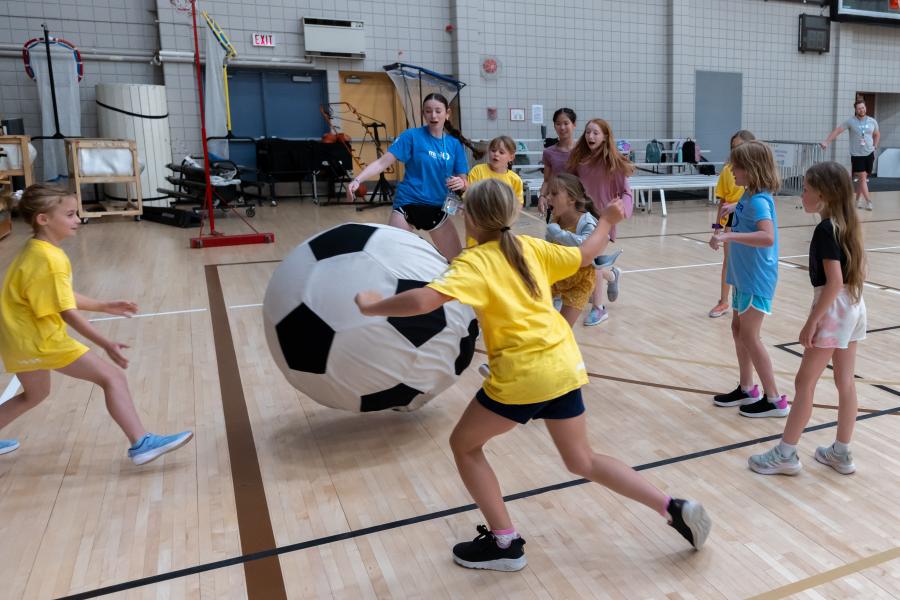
[228,68,328,176]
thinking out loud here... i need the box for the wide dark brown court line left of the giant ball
[204,265,287,600]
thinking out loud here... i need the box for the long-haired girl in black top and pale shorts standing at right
[749,162,866,475]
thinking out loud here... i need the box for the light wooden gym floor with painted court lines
[0,192,900,600]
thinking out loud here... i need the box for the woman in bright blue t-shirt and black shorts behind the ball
[347,94,469,261]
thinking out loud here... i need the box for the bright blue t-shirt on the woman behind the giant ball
[388,125,469,206]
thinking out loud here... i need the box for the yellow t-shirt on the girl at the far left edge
[0,239,88,373]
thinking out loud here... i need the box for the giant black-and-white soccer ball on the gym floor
[263,223,478,412]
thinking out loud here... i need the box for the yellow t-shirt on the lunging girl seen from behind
[429,235,588,404]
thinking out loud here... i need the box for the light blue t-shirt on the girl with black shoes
[725,192,778,300]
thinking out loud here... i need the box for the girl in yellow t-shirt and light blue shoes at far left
[0,185,193,465]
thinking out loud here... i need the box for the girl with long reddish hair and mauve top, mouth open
[566,119,634,326]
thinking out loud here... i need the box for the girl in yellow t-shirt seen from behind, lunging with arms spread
[356,179,711,571]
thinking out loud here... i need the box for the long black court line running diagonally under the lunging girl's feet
[59,398,900,600]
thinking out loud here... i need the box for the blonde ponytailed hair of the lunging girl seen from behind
[466,179,541,299]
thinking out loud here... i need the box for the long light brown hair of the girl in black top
[803,161,866,302]
